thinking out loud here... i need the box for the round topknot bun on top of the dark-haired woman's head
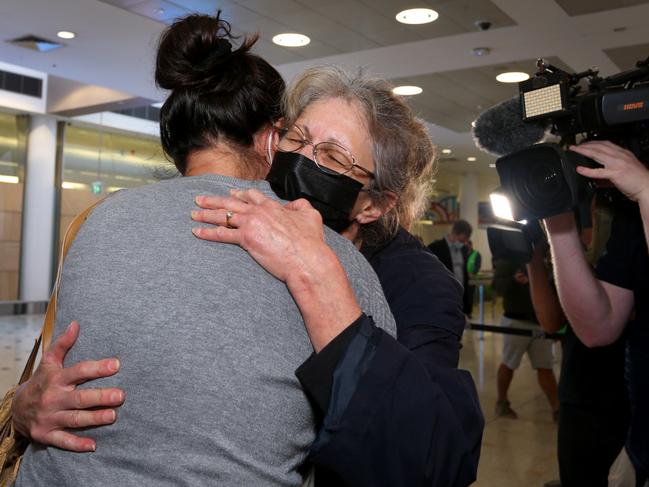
[155,15,257,90]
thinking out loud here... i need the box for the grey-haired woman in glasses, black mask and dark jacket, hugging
[194,66,484,486]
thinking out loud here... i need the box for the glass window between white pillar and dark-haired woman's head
[59,125,175,252]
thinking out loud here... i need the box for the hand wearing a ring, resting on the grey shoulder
[192,189,330,284]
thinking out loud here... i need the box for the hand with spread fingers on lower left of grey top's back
[12,321,124,452]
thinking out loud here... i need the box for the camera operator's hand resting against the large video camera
[570,141,649,201]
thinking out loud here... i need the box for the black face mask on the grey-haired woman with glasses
[266,151,363,232]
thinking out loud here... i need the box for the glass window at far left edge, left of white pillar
[0,112,27,301]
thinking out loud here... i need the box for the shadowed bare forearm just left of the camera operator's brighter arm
[527,245,566,333]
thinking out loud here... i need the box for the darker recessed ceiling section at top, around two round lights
[97,0,514,64]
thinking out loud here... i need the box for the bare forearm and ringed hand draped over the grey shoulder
[192,190,361,353]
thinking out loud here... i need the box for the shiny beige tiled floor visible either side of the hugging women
[0,309,560,487]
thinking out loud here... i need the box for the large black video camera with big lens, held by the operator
[496,58,649,221]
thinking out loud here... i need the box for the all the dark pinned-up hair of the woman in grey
[155,13,284,174]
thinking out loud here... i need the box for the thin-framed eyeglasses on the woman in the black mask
[277,125,374,178]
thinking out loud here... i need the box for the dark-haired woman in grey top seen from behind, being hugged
[13,15,395,487]
